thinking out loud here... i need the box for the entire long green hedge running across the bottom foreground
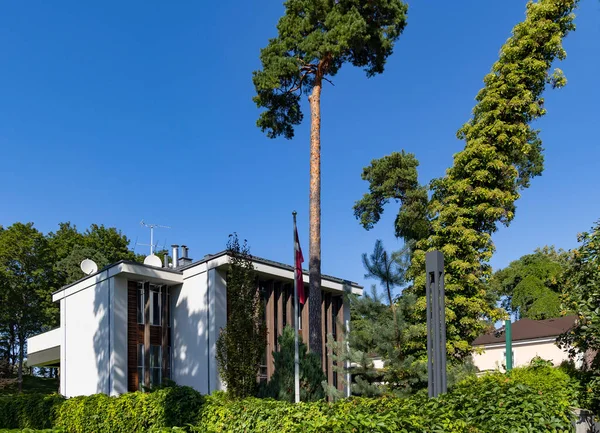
[0,367,578,433]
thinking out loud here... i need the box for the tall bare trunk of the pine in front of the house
[308,71,323,358]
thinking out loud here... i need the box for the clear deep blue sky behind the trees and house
[0,0,600,294]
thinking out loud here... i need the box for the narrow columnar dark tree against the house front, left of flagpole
[217,234,267,398]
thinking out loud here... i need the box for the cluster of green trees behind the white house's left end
[0,222,150,388]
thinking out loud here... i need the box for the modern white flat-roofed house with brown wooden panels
[27,246,362,397]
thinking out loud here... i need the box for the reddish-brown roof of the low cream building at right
[473,316,577,346]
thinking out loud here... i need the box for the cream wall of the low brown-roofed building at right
[473,338,569,371]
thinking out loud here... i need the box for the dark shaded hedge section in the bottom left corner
[0,394,64,429]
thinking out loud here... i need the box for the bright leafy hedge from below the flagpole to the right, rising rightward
[193,369,573,433]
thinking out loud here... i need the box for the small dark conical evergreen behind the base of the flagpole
[259,326,326,402]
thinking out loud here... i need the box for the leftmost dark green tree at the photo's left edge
[0,223,52,391]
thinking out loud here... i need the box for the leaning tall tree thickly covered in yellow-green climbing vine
[355,0,578,360]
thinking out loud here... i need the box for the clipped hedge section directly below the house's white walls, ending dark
[55,387,204,433]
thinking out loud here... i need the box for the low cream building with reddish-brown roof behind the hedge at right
[473,316,581,371]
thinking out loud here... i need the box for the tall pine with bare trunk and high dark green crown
[253,0,407,354]
